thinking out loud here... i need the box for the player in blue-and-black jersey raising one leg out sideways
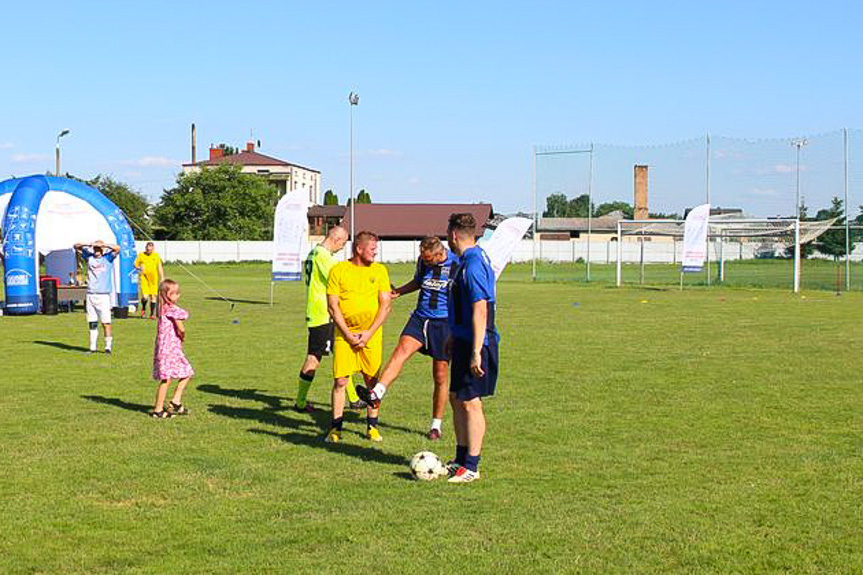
[357,237,458,441]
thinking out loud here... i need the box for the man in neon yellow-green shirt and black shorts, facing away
[294,226,365,413]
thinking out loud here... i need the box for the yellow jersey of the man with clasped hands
[327,261,390,332]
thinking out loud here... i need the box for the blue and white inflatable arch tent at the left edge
[0,176,138,315]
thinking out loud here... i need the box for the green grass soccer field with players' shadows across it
[0,264,863,574]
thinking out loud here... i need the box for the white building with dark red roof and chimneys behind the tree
[183,142,323,205]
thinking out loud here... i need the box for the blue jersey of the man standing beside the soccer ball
[449,246,497,344]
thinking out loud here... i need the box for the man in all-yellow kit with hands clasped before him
[326,232,391,443]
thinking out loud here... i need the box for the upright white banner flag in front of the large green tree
[273,190,309,282]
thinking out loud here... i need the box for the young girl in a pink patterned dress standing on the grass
[150,280,195,419]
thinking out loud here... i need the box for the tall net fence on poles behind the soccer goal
[533,129,863,290]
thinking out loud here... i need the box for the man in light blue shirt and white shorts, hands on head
[75,240,120,355]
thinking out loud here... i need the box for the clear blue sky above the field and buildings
[0,1,863,215]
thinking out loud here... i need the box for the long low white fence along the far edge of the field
[136,240,863,264]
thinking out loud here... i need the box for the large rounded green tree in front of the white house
[154,164,278,240]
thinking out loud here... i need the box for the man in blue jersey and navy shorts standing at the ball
[447,214,499,483]
